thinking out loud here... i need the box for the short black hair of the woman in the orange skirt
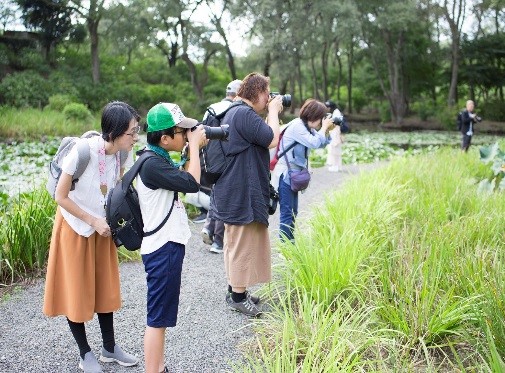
[101,101,140,141]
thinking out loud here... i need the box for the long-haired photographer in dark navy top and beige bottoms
[212,73,282,316]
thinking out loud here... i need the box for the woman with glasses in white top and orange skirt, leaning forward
[43,101,140,372]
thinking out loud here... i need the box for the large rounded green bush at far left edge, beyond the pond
[0,71,50,108]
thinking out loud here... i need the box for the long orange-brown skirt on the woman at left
[43,208,121,322]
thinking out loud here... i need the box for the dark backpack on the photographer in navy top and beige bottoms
[200,101,243,186]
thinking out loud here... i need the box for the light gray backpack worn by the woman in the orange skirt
[46,131,128,199]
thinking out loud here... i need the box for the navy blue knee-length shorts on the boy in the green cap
[142,242,186,328]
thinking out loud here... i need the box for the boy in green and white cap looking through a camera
[136,103,205,373]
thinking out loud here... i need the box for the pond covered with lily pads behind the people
[0,131,502,196]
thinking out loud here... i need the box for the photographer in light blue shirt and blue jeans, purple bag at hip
[276,99,334,242]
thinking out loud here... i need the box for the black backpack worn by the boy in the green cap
[105,151,177,251]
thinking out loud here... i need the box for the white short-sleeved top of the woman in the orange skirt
[61,136,119,237]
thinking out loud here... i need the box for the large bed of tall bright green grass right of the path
[242,149,505,372]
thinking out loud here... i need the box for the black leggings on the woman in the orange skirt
[67,312,116,359]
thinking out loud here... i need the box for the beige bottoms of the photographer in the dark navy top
[223,222,272,288]
